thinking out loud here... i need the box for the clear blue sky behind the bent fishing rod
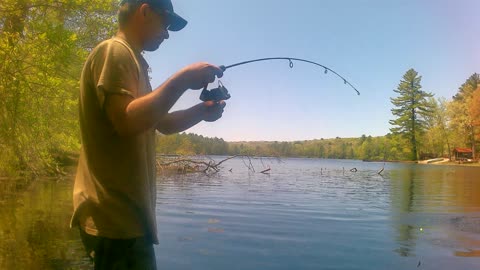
[142,0,480,141]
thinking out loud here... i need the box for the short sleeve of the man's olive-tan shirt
[91,41,139,107]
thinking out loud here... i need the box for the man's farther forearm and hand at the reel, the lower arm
[155,101,225,134]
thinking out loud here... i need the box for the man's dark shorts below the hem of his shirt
[80,229,157,270]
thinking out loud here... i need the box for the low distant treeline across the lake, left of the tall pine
[157,133,410,160]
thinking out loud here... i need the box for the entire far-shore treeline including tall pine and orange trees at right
[157,69,480,161]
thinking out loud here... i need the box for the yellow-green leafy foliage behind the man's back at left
[0,0,117,174]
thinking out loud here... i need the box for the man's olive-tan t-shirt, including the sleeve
[71,37,158,243]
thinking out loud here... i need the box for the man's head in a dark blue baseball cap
[118,0,187,51]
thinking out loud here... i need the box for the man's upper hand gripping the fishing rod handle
[174,62,223,90]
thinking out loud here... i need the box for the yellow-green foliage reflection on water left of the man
[0,179,89,269]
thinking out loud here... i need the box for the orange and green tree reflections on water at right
[390,166,480,262]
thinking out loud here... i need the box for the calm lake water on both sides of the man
[0,158,480,269]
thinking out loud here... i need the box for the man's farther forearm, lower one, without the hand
[156,103,205,134]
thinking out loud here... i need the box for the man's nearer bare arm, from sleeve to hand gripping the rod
[104,63,223,136]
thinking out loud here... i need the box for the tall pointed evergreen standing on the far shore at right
[390,69,433,160]
